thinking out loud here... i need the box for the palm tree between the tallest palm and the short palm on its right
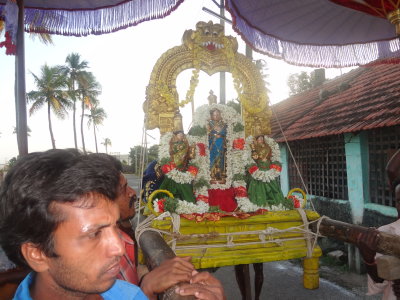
[78,72,101,153]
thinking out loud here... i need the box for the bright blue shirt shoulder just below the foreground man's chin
[101,280,148,300]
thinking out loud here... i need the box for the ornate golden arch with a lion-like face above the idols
[143,21,271,136]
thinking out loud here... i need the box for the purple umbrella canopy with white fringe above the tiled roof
[226,0,400,67]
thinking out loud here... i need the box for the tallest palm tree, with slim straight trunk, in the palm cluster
[63,53,88,149]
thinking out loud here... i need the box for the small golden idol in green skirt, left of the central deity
[160,130,196,203]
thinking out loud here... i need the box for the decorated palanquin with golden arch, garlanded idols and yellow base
[139,22,321,288]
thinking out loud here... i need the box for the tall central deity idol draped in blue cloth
[207,109,227,184]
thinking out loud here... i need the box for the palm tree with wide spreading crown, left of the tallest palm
[27,64,71,149]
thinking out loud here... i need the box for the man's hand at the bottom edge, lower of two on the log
[175,270,226,300]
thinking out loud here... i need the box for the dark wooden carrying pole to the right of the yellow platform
[310,217,400,258]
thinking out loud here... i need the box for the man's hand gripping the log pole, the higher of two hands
[140,257,194,299]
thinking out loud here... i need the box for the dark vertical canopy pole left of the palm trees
[15,0,28,156]
